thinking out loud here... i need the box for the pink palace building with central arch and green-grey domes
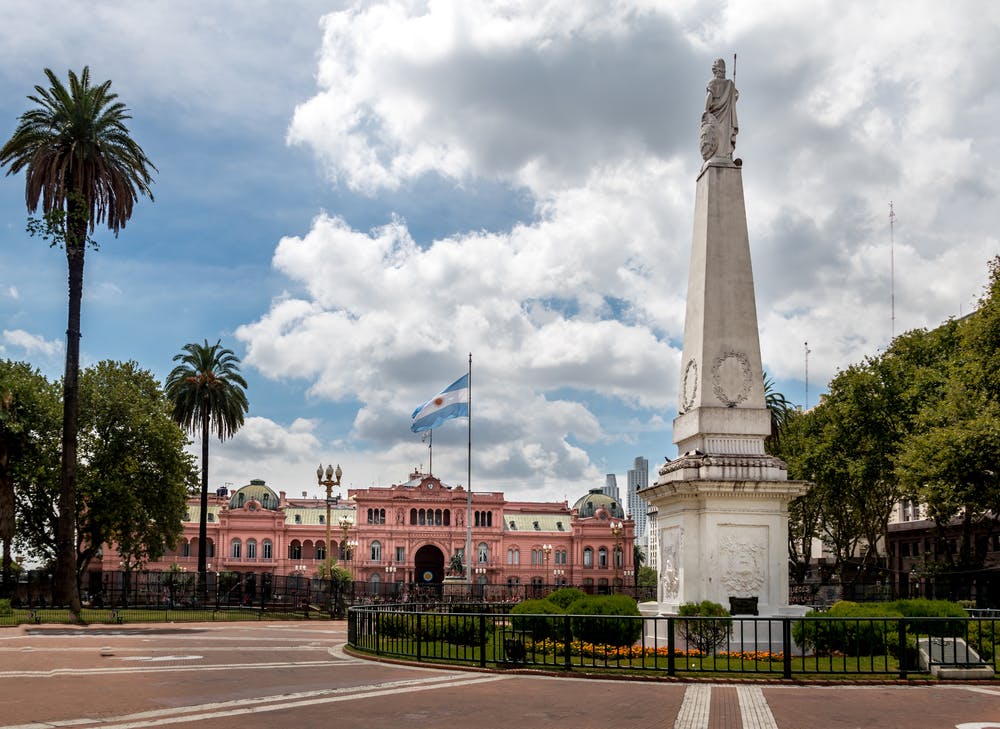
[102,473,635,591]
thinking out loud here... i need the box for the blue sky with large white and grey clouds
[0,0,1000,503]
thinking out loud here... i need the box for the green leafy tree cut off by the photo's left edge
[0,360,60,592]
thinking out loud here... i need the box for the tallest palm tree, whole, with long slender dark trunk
[0,67,156,615]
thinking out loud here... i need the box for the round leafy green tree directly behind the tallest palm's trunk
[11,362,196,578]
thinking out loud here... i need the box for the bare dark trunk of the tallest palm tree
[53,242,86,618]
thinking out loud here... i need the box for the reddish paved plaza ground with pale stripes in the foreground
[0,622,1000,729]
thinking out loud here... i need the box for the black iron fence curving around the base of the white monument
[348,603,1000,679]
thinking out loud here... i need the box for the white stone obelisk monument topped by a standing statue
[642,59,808,615]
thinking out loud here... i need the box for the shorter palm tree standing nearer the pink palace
[165,339,247,595]
